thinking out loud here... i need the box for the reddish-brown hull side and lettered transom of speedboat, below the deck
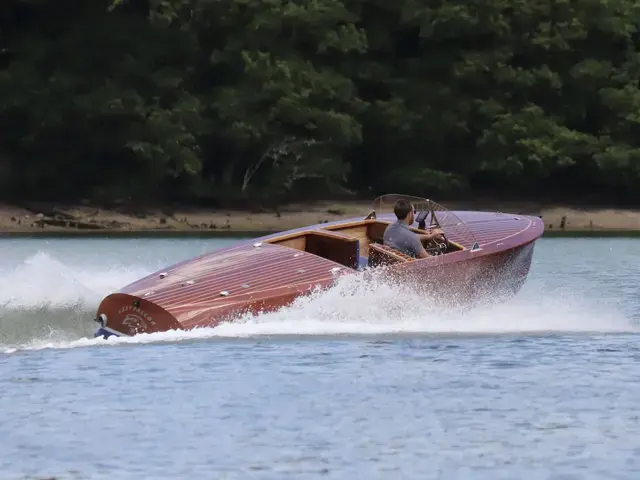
[96,242,535,337]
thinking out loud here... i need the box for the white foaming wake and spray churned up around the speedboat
[0,249,638,353]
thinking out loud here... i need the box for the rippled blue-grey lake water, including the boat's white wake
[0,238,640,480]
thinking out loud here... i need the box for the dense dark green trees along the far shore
[0,0,640,206]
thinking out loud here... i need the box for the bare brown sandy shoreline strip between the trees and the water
[0,201,640,237]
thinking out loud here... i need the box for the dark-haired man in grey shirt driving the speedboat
[382,198,444,258]
